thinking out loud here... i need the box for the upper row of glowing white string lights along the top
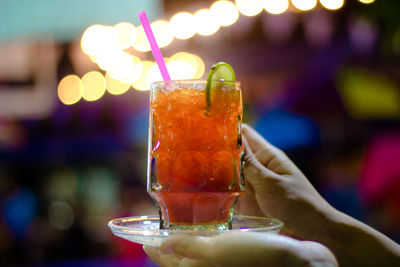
[81,0,346,58]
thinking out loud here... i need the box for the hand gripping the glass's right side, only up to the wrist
[236,124,334,240]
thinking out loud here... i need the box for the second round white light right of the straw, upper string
[169,12,196,40]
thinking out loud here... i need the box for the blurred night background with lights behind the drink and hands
[0,0,400,266]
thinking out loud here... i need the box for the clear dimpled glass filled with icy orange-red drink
[147,80,244,230]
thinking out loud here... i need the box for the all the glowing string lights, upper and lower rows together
[72,0,346,105]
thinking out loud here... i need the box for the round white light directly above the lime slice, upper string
[210,0,239,26]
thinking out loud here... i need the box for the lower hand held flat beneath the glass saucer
[144,232,337,267]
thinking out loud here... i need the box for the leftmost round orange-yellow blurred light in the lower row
[57,75,83,105]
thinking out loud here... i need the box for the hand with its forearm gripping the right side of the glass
[237,125,400,266]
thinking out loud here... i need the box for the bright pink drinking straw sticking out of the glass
[138,11,171,81]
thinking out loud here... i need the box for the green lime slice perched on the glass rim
[206,62,236,107]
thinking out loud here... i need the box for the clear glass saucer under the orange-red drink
[108,215,283,247]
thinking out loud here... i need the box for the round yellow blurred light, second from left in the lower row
[82,71,106,101]
